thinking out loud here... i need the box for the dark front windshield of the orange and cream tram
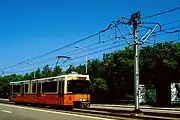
[68,80,90,94]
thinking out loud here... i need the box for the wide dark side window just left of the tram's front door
[42,81,57,93]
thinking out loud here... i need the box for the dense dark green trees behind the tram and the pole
[0,43,180,105]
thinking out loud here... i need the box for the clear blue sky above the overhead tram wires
[0,0,180,75]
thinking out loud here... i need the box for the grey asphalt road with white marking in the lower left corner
[0,103,116,120]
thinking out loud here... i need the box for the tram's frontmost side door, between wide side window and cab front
[58,80,64,105]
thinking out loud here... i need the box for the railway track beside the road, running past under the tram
[0,101,176,120]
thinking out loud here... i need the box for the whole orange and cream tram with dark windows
[9,74,90,108]
